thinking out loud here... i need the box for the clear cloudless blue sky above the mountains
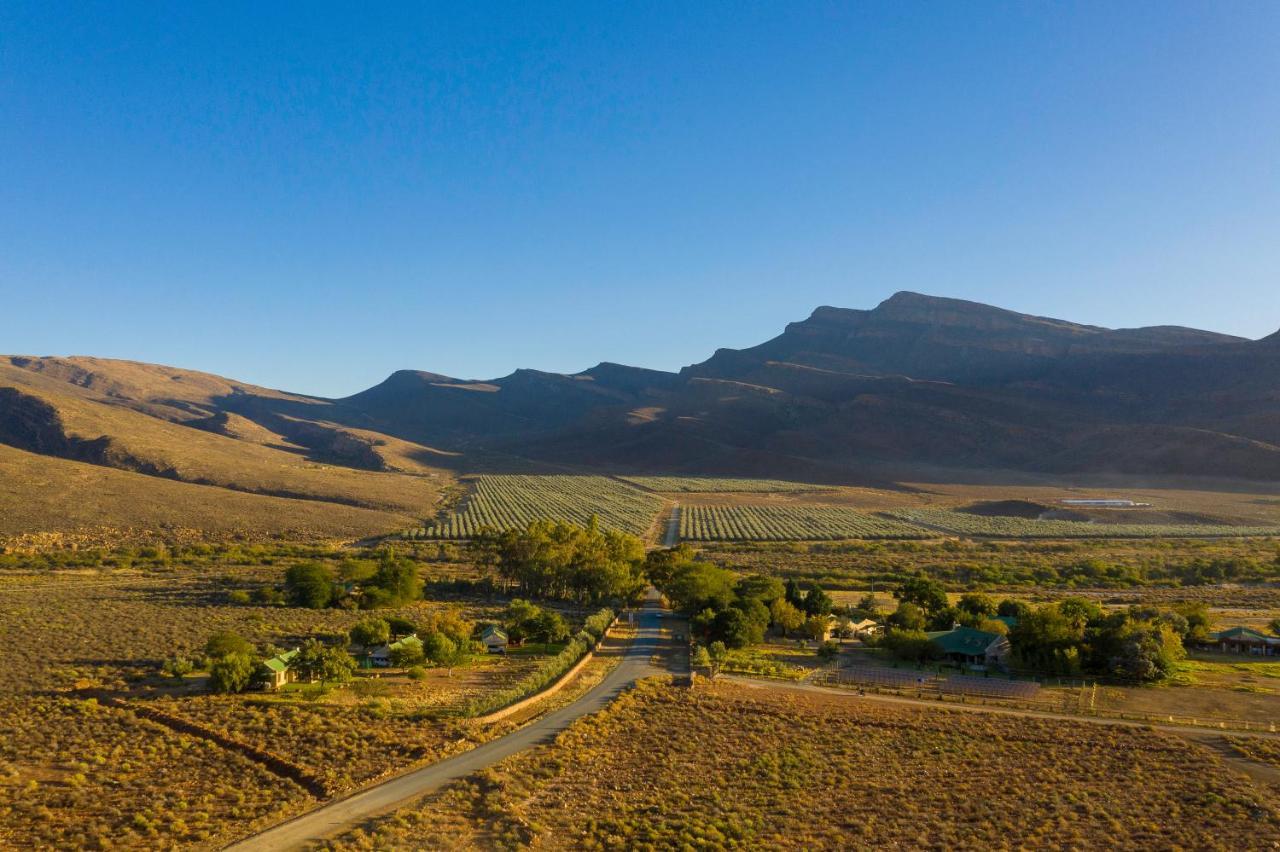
[0,0,1280,395]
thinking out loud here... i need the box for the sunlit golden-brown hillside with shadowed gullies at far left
[0,357,452,539]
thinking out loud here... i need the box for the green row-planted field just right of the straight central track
[680,505,936,541]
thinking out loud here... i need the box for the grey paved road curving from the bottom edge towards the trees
[228,592,664,852]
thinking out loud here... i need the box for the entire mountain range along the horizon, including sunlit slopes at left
[0,293,1280,532]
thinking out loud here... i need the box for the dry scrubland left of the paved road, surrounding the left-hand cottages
[0,565,560,848]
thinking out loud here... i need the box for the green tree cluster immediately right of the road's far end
[648,545,833,649]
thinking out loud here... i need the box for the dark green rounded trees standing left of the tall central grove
[279,548,422,609]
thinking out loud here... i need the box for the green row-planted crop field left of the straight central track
[407,476,663,539]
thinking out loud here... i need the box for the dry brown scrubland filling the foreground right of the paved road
[322,682,1280,849]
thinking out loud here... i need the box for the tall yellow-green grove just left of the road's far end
[470,516,646,605]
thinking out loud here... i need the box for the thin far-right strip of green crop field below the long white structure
[887,509,1280,539]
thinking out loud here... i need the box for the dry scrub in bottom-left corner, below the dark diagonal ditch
[0,696,307,849]
